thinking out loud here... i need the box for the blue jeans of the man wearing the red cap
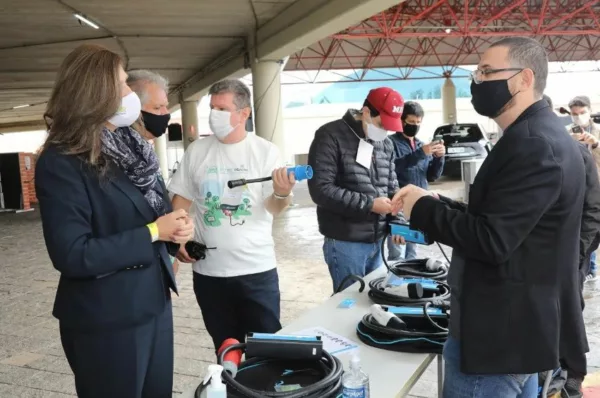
[323,238,383,291]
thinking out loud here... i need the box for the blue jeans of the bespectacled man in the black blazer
[443,337,538,398]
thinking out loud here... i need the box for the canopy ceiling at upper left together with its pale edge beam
[0,0,404,132]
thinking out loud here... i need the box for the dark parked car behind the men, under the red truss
[433,123,492,178]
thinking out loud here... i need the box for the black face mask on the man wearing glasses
[471,79,513,119]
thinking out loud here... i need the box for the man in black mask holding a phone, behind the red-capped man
[388,101,446,261]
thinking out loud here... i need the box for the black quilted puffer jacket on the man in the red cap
[308,110,398,243]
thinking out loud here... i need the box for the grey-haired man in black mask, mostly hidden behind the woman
[127,69,179,275]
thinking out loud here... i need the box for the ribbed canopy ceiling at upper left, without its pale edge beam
[0,0,300,131]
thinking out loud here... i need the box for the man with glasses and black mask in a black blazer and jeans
[393,37,587,398]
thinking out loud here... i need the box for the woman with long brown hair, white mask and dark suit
[35,45,193,398]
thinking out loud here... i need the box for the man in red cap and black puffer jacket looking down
[308,87,404,291]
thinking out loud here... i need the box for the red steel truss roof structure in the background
[286,0,600,78]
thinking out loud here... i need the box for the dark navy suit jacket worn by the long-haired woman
[35,147,177,330]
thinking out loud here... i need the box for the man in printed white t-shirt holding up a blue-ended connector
[169,80,296,349]
